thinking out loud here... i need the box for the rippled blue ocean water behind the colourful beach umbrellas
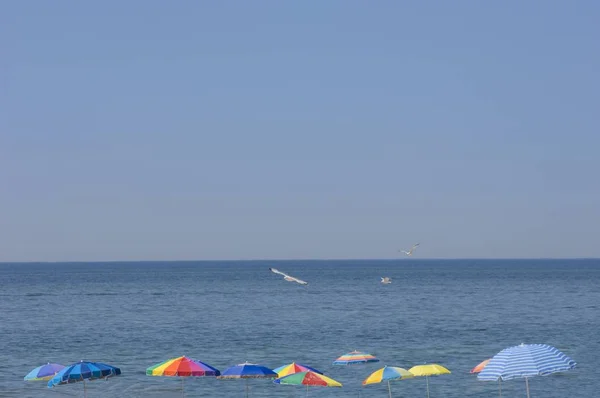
[0,259,600,398]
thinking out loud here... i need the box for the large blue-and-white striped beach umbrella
[477,344,577,398]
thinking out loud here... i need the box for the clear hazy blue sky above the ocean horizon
[0,0,600,262]
